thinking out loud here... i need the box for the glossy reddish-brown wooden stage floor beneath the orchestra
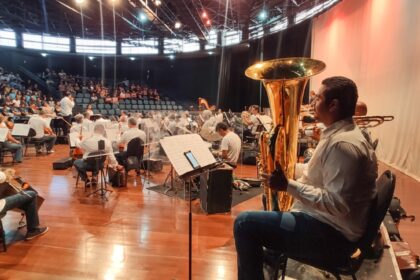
[0,145,420,280]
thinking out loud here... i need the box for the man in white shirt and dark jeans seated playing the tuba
[234,77,377,280]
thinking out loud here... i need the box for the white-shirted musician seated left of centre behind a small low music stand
[74,124,118,186]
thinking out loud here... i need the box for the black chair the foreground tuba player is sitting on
[273,170,395,280]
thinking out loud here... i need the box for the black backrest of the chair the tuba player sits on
[358,170,395,253]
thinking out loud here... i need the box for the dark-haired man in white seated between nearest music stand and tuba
[216,122,242,167]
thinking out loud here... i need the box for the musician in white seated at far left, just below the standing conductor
[28,110,57,154]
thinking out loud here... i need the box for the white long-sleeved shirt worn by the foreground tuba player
[287,119,378,242]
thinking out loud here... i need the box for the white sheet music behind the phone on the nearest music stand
[160,134,216,176]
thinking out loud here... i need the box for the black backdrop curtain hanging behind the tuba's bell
[218,21,311,112]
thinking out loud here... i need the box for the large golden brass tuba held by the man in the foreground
[245,57,325,211]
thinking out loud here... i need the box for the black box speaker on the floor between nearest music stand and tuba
[200,164,233,214]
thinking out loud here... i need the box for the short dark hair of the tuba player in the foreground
[322,76,358,119]
